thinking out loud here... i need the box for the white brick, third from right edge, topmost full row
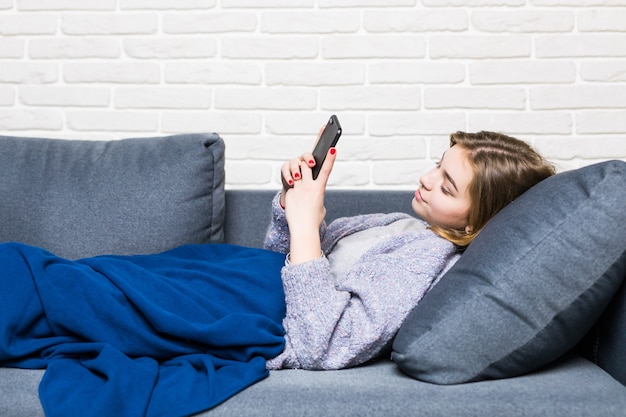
[363,9,469,33]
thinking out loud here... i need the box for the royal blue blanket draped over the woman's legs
[0,243,285,417]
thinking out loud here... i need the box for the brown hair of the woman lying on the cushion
[431,131,555,247]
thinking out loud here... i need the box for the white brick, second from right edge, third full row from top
[470,60,576,84]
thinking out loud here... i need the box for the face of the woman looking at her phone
[412,145,474,231]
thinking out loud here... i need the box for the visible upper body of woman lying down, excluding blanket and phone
[265,132,554,369]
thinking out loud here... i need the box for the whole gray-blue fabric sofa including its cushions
[0,134,626,417]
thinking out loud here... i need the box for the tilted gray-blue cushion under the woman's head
[393,161,626,384]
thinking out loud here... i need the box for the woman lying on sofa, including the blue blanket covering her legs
[0,132,553,417]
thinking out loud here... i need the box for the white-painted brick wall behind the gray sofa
[0,0,626,188]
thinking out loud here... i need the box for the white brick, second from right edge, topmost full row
[472,9,574,33]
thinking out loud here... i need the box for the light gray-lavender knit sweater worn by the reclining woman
[265,195,459,369]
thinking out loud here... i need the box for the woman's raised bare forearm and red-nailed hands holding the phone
[280,148,336,264]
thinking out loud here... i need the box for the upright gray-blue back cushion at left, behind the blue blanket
[0,134,224,258]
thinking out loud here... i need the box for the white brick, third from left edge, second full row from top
[124,37,217,59]
